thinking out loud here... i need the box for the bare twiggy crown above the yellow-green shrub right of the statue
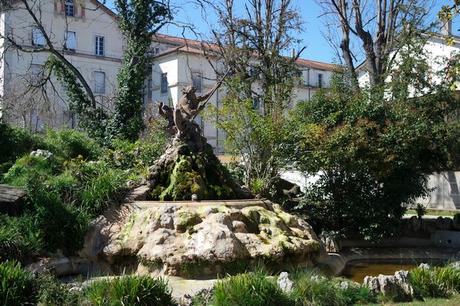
[197,0,304,114]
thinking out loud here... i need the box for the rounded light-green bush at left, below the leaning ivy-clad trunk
[44,129,102,160]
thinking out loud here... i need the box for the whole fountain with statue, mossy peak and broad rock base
[81,81,320,277]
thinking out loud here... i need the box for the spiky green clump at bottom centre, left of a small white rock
[212,272,292,306]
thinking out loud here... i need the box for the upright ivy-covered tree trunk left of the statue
[109,0,171,140]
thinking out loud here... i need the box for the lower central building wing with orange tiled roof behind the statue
[152,35,336,152]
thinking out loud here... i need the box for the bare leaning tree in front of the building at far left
[0,0,108,130]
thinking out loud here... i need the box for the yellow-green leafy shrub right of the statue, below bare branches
[211,78,286,197]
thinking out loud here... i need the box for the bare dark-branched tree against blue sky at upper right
[318,0,429,89]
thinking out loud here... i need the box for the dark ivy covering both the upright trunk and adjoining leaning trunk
[47,0,172,143]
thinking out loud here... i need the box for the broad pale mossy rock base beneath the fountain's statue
[83,200,320,276]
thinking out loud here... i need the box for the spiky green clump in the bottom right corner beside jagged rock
[409,266,460,298]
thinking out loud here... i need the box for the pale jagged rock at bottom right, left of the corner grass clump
[364,271,414,302]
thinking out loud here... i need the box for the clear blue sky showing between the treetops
[107,0,460,62]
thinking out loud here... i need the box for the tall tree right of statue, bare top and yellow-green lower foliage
[197,0,303,194]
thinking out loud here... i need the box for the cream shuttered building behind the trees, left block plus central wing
[0,0,335,151]
